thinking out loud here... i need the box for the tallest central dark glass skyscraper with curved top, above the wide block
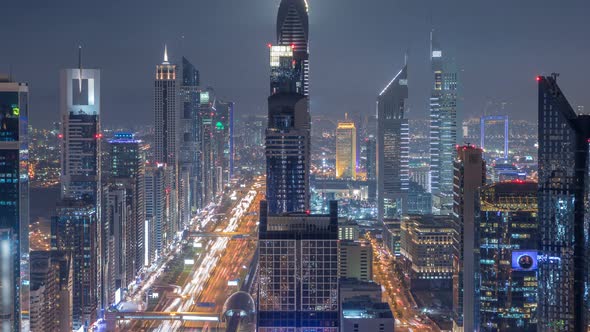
[266,0,311,214]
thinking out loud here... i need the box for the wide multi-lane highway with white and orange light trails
[124,179,264,331]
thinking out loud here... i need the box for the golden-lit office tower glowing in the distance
[336,114,356,180]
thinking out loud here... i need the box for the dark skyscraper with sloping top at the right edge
[537,74,590,331]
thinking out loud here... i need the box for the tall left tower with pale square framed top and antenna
[57,48,104,329]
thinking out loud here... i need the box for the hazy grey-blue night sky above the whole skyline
[0,0,590,127]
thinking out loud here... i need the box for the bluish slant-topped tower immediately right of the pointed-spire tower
[178,57,202,215]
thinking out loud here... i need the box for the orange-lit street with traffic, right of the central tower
[367,235,440,332]
